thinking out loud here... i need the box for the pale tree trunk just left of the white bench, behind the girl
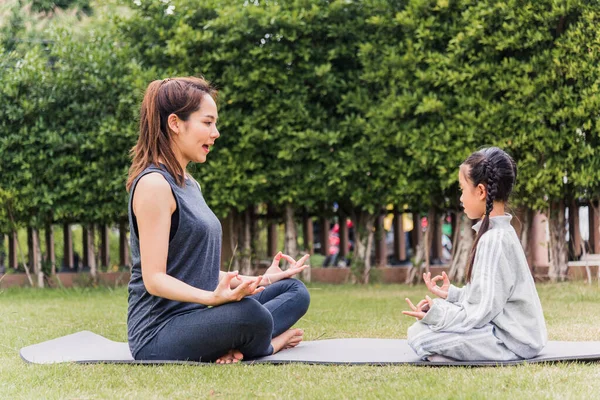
[548,200,567,282]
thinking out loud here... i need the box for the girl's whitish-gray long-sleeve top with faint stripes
[422,214,548,358]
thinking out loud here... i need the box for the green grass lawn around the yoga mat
[0,283,600,399]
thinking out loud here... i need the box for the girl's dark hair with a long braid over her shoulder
[463,147,517,282]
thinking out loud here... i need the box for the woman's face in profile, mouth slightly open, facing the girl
[175,95,220,164]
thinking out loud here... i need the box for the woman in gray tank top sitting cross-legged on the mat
[127,78,310,363]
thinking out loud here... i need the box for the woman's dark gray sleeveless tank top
[127,165,222,357]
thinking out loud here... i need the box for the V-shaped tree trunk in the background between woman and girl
[352,211,376,283]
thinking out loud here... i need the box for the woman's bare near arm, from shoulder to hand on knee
[133,173,260,306]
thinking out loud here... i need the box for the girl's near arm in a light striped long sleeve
[422,230,516,333]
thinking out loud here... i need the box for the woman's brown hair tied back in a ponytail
[126,77,217,191]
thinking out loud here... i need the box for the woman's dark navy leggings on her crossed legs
[135,279,310,362]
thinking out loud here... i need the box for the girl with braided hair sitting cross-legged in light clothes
[403,147,547,361]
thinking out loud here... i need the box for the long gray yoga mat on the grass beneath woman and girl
[20,331,600,366]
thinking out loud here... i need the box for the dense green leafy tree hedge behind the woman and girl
[0,0,600,278]
